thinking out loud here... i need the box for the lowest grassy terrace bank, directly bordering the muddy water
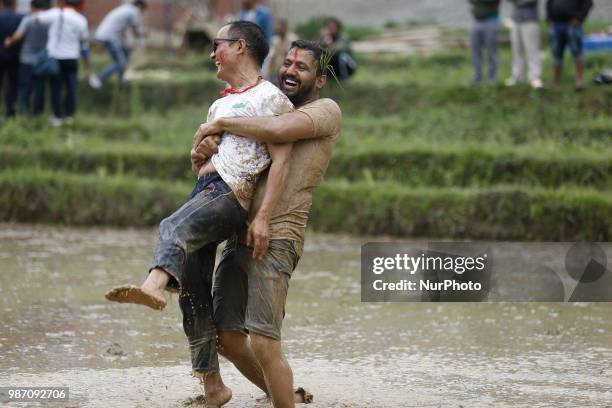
[0,169,612,241]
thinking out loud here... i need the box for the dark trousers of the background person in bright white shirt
[51,59,79,118]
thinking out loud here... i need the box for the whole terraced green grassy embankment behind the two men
[0,42,612,240]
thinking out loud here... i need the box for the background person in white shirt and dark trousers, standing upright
[36,0,89,126]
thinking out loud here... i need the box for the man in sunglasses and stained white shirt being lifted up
[106,22,293,405]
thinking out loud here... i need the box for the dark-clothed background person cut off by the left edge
[0,0,23,118]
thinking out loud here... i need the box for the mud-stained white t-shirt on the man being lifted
[208,80,293,211]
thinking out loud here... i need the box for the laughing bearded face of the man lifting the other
[278,47,325,106]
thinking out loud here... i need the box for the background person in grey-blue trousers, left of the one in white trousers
[469,0,500,84]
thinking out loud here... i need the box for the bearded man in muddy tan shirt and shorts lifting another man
[192,40,342,408]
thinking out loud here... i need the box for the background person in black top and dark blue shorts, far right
[546,0,593,90]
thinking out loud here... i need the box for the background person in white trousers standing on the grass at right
[506,0,542,89]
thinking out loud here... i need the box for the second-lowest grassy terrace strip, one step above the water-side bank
[0,144,612,189]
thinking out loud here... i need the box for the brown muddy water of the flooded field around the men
[0,225,612,408]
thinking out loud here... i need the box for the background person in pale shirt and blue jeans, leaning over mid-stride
[89,0,147,89]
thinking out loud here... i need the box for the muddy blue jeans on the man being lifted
[151,173,247,376]
